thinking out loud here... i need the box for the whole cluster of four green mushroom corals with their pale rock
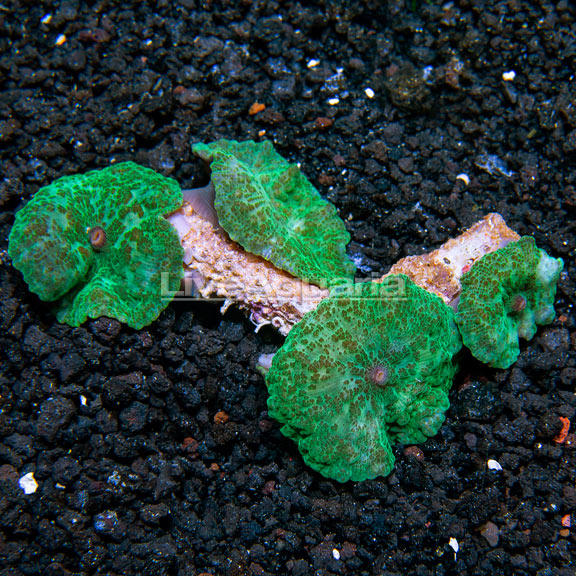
[9,140,563,482]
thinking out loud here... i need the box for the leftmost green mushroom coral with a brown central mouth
[8,162,183,329]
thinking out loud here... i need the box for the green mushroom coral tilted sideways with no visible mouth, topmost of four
[192,140,354,285]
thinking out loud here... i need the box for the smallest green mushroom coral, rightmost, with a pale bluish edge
[456,236,564,368]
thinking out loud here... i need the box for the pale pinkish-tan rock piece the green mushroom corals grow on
[168,204,519,336]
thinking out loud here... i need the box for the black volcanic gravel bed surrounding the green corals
[0,0,576,576]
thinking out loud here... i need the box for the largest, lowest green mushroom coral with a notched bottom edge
[266,274,461,482]
